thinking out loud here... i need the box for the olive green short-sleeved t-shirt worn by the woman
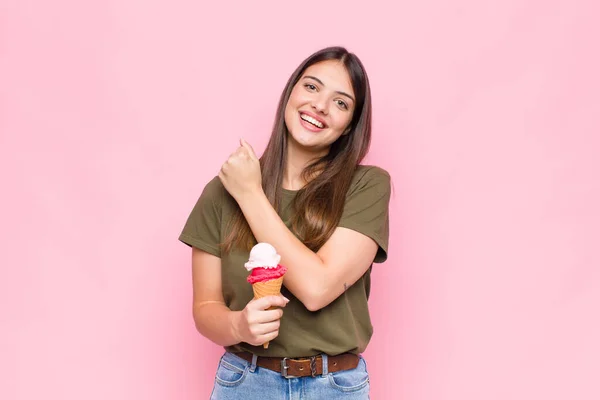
[179,166,390,357]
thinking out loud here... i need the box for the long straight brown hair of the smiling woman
[222,47,371,252]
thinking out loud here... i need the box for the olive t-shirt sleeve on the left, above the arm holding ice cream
[179,177,225,257]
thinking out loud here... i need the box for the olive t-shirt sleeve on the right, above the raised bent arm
[338,167,391,263]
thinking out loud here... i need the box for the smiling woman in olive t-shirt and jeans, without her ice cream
[179,47,390,400]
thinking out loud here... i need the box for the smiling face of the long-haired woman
[285,60,355,154]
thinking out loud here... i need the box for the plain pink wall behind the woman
[0,0,600,400]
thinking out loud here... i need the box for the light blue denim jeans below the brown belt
[210,352,369,400]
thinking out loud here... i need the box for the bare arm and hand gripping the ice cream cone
[192,248,287,346]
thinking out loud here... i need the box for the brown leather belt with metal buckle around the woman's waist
[234,352,359,378]
